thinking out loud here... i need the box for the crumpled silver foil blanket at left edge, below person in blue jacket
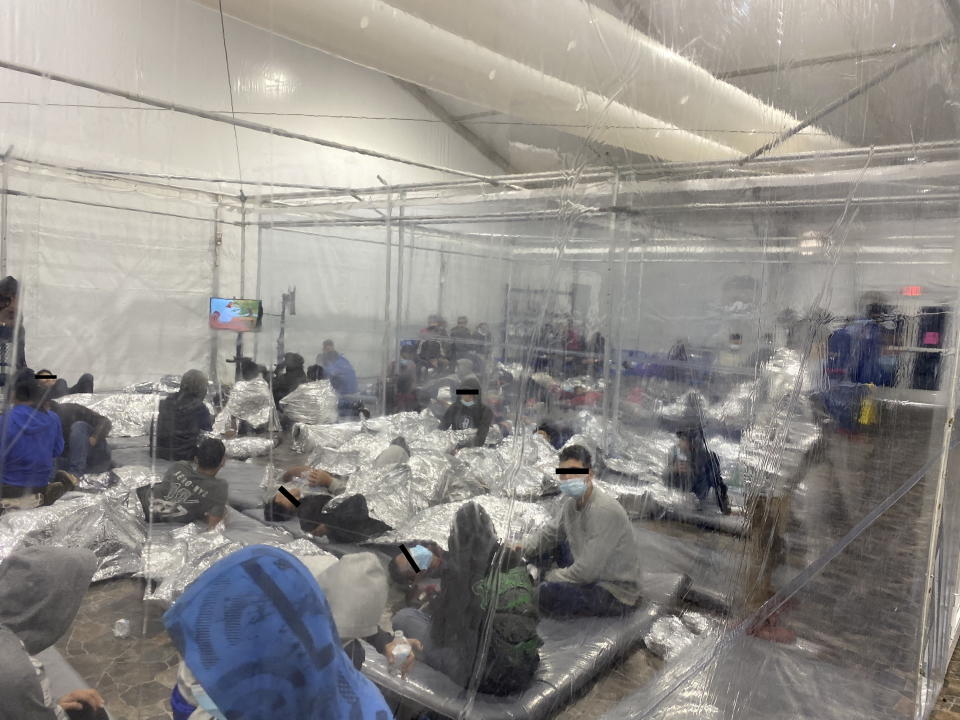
[0,467,155,582]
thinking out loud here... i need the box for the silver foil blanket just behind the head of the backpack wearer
[377,495,550,548]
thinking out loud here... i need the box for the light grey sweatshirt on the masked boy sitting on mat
[523,485,640,605]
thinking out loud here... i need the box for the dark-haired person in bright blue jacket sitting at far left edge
[0,368,77,510]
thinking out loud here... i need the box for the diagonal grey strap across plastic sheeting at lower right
[634,430,960,717]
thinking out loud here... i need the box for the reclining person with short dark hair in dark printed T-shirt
[137,438,227,527]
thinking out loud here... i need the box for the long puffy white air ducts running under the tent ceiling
[202,0,842,161]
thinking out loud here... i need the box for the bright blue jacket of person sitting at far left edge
[0,405,63,488]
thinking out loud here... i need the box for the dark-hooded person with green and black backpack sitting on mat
[393,502,543,695]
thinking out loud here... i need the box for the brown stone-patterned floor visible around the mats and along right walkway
[50,400,960,720]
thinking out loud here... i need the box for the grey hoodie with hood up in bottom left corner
[0,547,97,720]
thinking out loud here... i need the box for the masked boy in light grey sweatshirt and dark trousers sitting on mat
[520,445,640,616]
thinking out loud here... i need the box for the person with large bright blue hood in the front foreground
[163,545,393,720]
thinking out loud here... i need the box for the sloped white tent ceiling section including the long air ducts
[200,0,956,171]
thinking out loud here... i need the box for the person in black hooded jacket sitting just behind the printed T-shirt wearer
[151,370,213,460]
